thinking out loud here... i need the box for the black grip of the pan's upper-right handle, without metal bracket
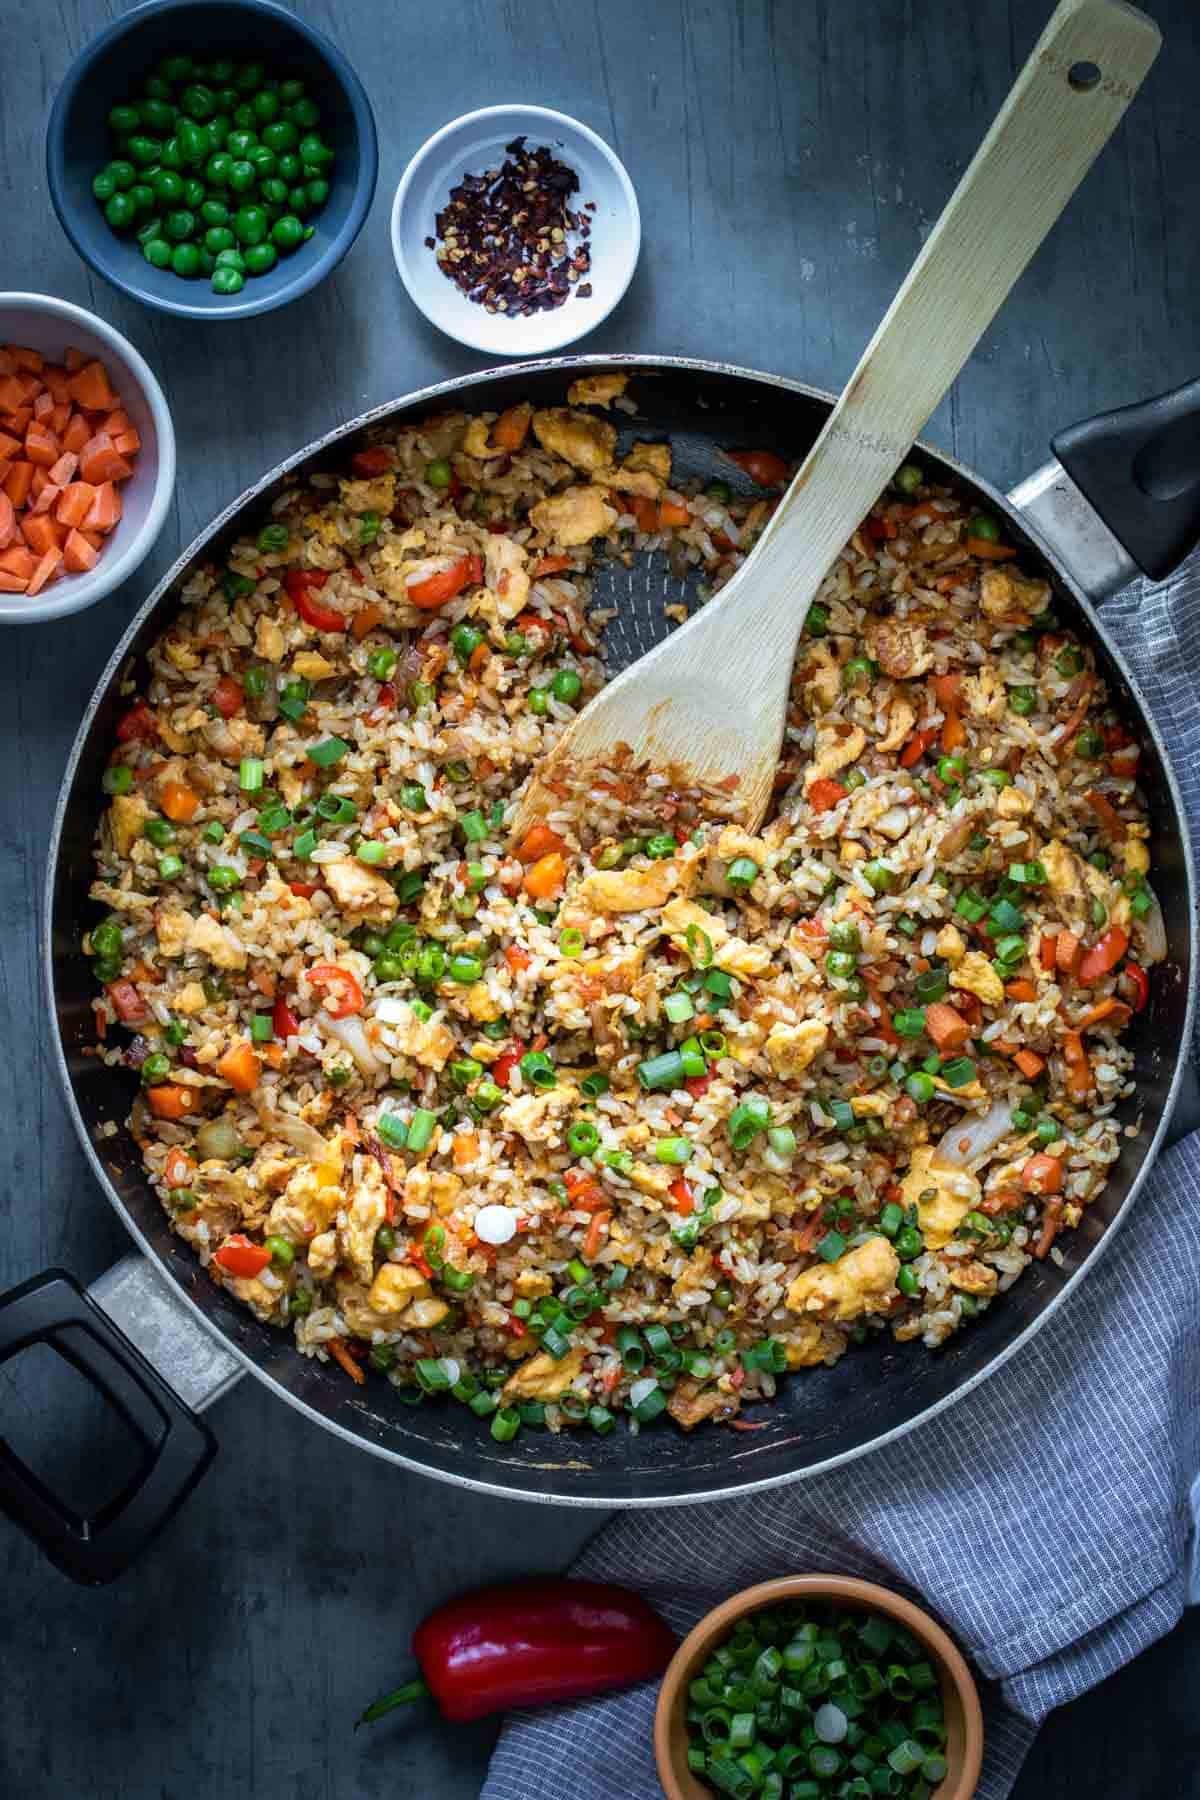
[1052,382,1200,581]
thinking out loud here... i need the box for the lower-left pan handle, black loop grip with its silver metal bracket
[0,1256,241,1586]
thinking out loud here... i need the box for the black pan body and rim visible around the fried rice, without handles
[50,364,1191,1505]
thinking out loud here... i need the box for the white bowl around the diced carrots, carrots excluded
[0,293,175,625]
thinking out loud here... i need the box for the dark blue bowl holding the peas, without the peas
[45,0,380,319]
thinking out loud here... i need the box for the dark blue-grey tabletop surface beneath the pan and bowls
[0,0,1200,1800]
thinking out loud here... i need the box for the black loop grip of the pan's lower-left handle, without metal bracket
[0,1269,216,1588]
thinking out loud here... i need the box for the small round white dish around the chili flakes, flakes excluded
[392,106,642,356]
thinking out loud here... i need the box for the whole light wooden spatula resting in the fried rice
[515,0,1162,839]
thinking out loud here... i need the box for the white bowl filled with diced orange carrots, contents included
[0,293,175,625]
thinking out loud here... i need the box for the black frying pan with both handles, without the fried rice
[0,356,1200,1582]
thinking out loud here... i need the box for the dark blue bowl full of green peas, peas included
[47,0,378,319]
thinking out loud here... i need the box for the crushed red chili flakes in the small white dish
[433,137,596,319]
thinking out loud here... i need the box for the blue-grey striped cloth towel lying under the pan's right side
[484,556,1200,1800]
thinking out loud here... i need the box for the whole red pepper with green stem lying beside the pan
[358,1577,676,1724]
